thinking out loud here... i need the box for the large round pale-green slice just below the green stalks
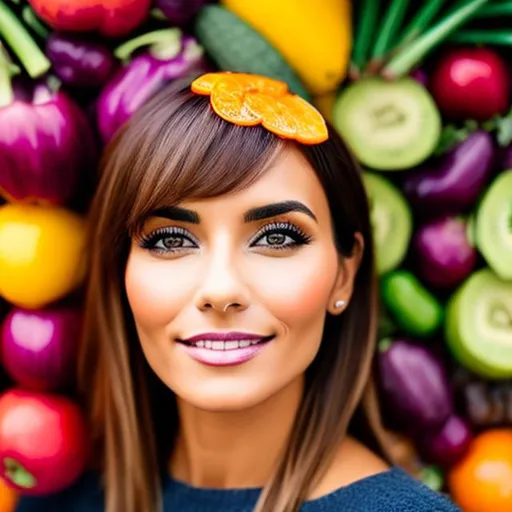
[333,77,442,171]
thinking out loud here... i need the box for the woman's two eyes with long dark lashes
[139,222,312,254]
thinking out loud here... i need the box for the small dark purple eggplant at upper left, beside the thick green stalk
[46,32,116,87]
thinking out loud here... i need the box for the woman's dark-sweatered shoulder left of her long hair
[15,473,104,512]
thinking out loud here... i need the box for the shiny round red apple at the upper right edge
[430,48,510,121]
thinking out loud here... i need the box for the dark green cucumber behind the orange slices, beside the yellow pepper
[195,5,311,101]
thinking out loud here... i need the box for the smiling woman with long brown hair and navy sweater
[19,75,456,512]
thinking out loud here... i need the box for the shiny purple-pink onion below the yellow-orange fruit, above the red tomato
[0,307,81,391]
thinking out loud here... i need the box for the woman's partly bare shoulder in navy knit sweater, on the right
[304,438,460,512]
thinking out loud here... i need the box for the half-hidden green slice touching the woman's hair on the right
[363,172,412,275]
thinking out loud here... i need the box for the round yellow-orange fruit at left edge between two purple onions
[0,203,86,309]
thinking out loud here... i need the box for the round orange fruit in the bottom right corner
[447,429,512,512]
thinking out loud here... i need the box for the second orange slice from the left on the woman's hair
[210,76,262,126]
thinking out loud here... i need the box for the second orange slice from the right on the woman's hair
[245,93,297,139]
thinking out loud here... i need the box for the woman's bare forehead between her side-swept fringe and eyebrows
[181,146,329,215]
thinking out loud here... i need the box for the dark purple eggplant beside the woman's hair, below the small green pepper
[378,339,453,430]
